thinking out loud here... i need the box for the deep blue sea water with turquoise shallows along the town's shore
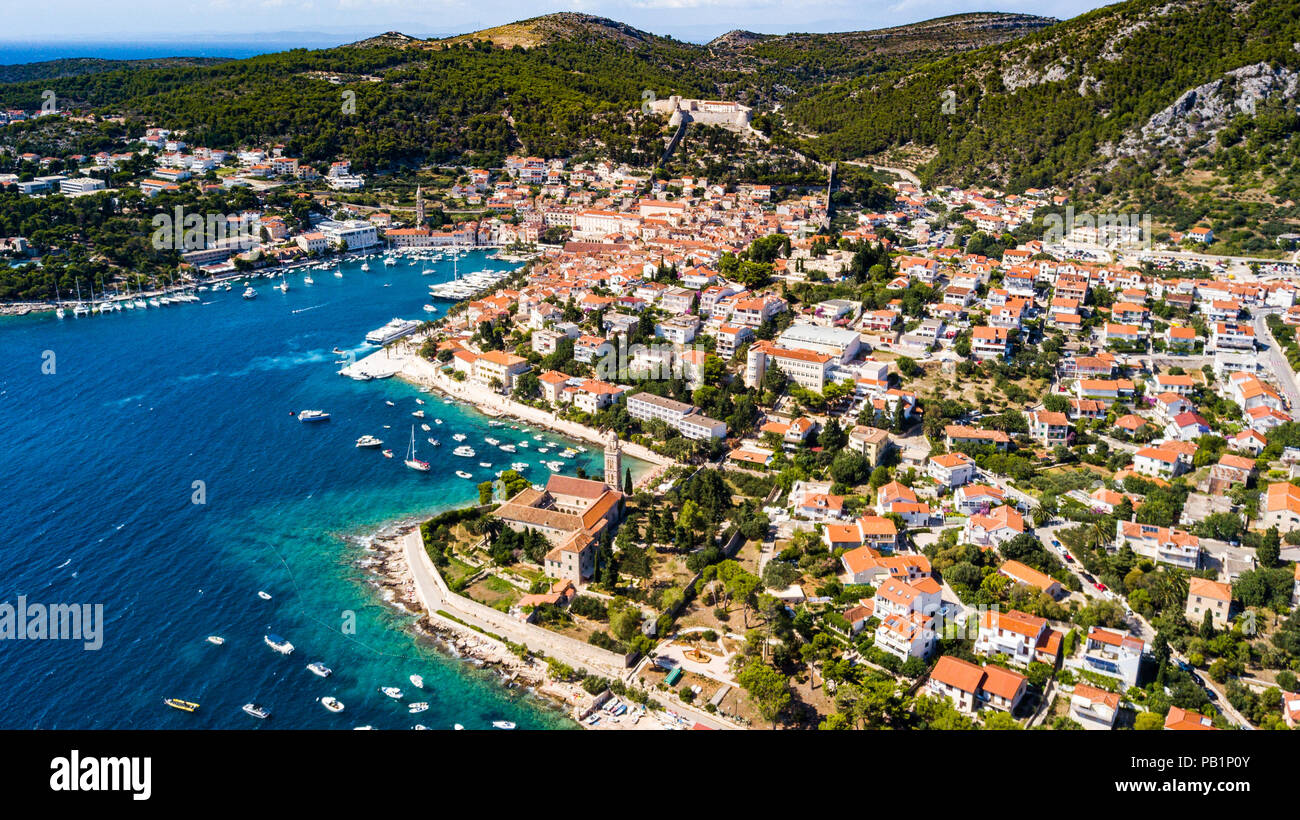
[0,253,624,729]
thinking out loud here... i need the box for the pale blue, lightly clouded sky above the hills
[0,0,1106,45]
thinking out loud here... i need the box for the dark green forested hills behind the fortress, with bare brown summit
[0,13,1045,169]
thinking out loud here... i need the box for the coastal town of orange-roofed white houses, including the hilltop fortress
[0,86,1300,729]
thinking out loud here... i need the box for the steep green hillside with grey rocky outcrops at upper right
[787,0,1300,198]
